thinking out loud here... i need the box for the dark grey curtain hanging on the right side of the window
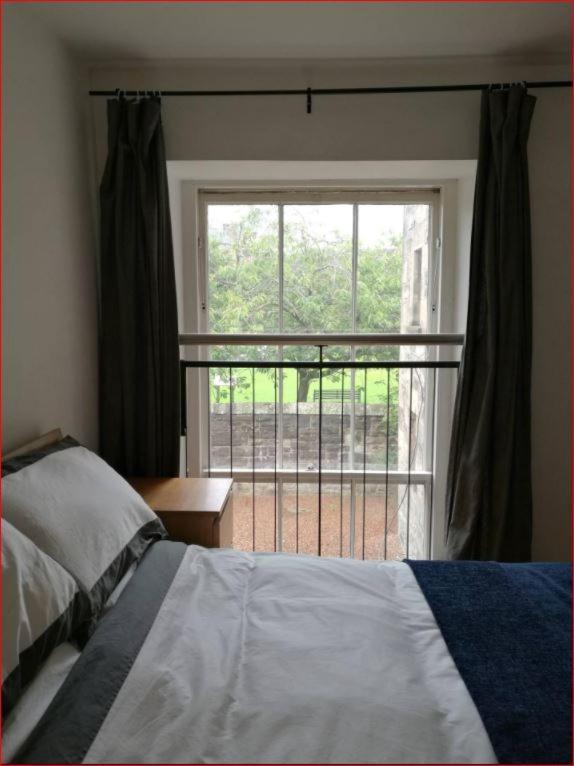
[446,86,536,561]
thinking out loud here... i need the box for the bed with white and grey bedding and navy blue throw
[3,440,572,763]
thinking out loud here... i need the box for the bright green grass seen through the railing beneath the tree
[211,368,398,404]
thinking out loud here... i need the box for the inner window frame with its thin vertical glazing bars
[192,185,443,556]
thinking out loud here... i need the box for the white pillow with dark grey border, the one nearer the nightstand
[2,436,166,617]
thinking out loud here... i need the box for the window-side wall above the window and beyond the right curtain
[91,59,570,559]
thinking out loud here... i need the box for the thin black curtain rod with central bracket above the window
[89,80,572,114]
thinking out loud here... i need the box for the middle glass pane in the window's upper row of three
[283,205,353,333]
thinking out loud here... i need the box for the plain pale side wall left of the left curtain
[2,4,97,449]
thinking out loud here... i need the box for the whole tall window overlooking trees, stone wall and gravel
[194,190,440,558]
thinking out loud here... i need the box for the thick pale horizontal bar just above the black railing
[179,332,464,346]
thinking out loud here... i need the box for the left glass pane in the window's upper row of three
[207,205,279,333]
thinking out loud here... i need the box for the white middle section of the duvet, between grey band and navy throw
[84,546,496,763]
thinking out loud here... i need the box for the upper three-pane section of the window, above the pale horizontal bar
[200,191,439,333]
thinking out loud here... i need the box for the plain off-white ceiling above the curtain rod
[15,2,571,61]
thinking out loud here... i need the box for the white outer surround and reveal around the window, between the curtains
[168,160,476,558]
